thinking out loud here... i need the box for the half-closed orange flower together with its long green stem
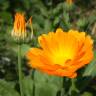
[11,13,33,96]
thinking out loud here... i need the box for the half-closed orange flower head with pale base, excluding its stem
[11,13,32,40]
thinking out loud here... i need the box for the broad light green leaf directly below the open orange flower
[34,71,62,96]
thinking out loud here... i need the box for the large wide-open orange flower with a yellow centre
[27,28,93,78]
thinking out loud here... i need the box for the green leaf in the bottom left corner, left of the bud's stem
[0,80,20,96]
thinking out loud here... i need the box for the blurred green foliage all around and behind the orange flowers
[0,0,96,96]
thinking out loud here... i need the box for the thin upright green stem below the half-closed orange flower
[18,44,24,96]
